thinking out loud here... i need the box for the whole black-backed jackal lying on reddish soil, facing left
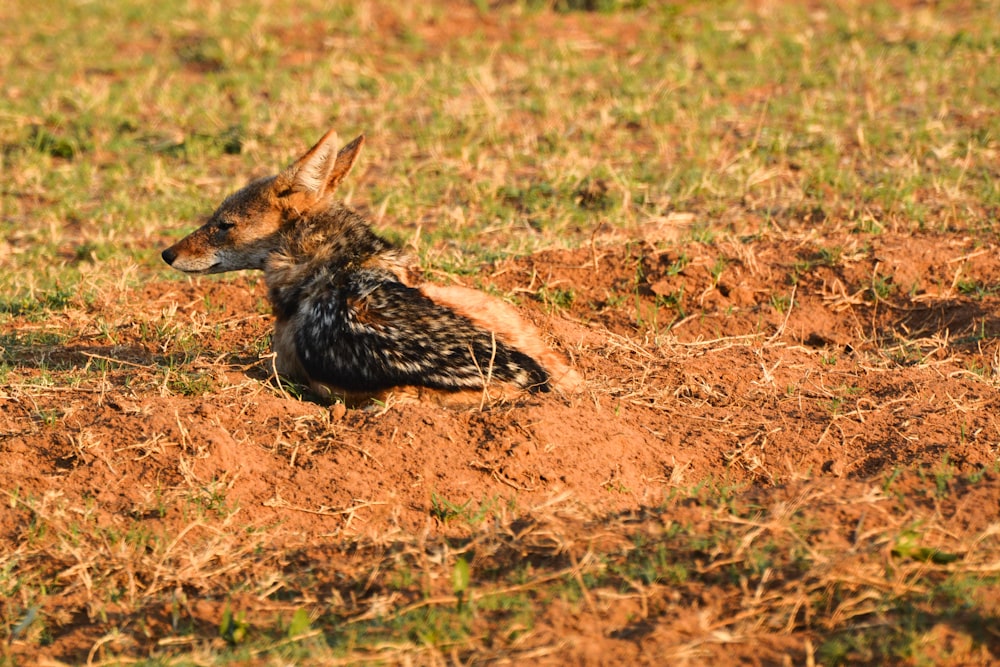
[162,130,580,405]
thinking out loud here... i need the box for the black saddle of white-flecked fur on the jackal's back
[275,260,548,392]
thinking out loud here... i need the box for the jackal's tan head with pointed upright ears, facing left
[162,130,365,273]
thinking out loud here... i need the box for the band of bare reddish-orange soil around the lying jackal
[0,223,1000,664]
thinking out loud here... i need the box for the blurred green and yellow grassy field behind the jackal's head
[0,0,1000,298]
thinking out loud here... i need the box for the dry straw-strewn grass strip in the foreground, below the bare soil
[3,462,1000,664]
